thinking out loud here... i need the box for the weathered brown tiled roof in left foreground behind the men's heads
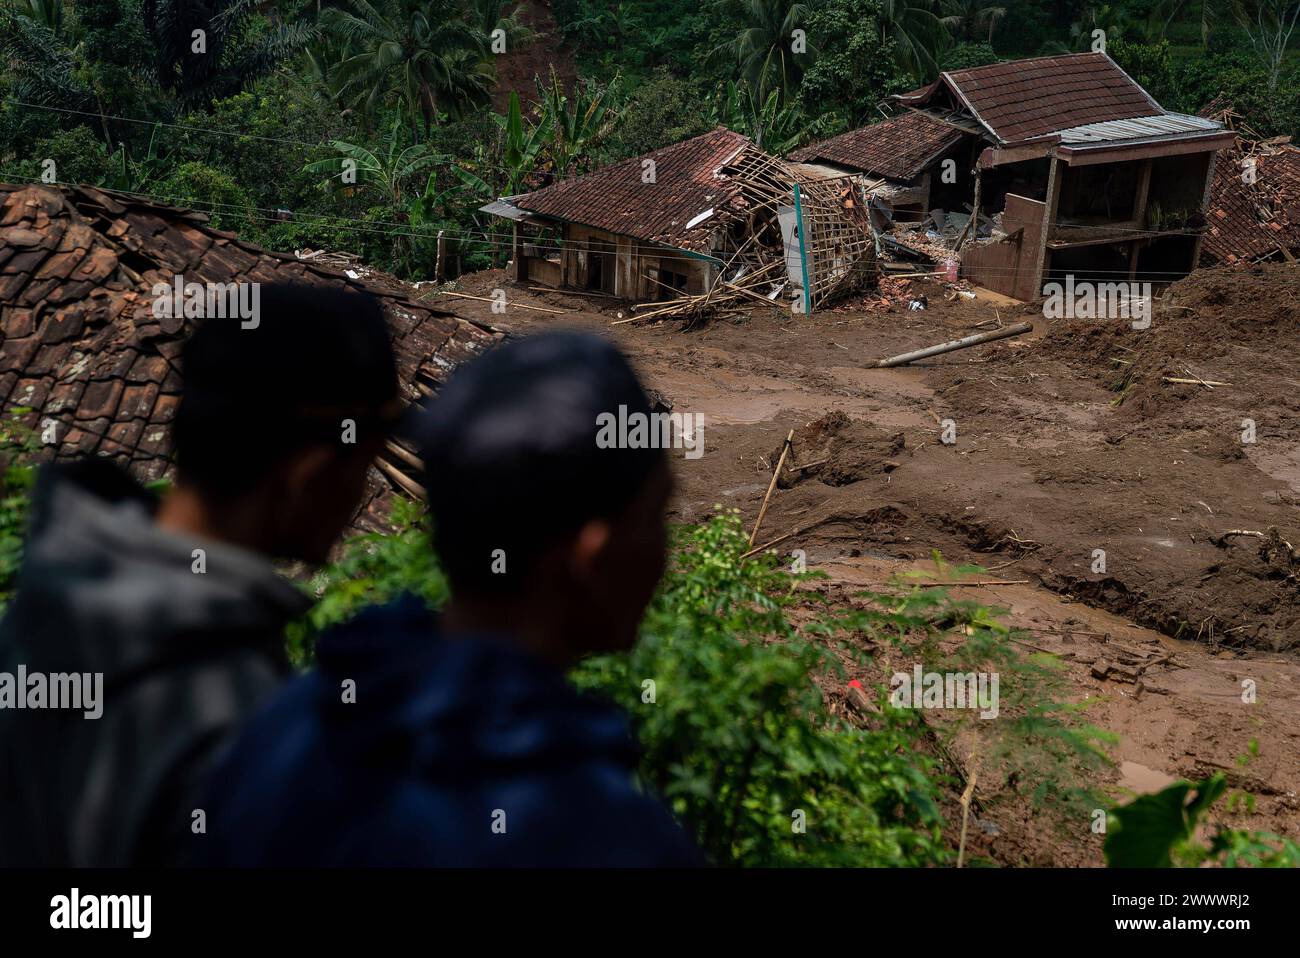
[0,185,499,480]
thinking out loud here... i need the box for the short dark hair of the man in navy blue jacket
[416,331,666,595]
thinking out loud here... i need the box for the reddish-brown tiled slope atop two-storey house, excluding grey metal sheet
[898,53,1165,143]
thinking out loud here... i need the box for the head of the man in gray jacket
[173,283,399,562]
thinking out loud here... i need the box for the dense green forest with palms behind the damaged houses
[0,0,1300,278]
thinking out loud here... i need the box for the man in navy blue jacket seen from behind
[207,328,701,866]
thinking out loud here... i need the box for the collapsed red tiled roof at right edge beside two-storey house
[1201,146,1300,263]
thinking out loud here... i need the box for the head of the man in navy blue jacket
[421,333,672,660]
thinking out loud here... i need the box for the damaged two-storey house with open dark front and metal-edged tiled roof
[894,53,1234,300]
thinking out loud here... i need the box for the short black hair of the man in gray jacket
[172,283,398,497]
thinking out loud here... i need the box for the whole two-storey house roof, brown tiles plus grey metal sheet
[896,53,1223,152]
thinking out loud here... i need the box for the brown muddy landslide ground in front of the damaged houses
[431,264,1300,864]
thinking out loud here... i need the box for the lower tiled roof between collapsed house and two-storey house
[790,112,962,181]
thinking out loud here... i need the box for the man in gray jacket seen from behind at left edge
[0,286,398,866]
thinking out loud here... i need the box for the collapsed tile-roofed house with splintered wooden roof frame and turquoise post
[482,127,874,315]
